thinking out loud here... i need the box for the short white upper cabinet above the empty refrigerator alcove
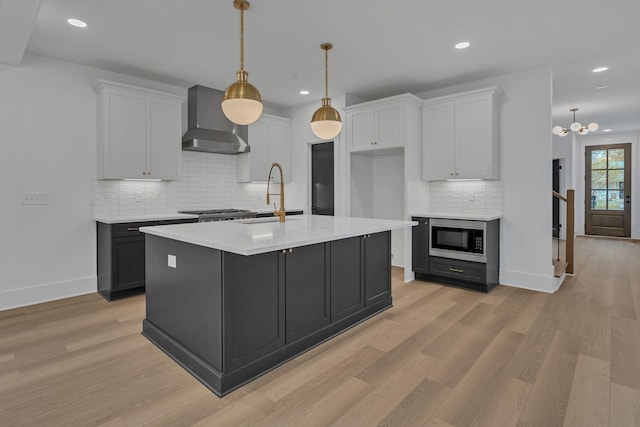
[345,94,420,152]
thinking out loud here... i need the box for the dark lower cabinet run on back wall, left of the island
[97,219,197,301]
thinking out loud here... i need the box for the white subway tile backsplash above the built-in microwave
[429,181,502,215]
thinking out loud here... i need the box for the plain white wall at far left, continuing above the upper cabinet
[0,55,186,310]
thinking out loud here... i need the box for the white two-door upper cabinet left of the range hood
[95,80,184,180]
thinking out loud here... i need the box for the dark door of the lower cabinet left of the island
[111,236,145,292]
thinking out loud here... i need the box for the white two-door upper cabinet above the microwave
[422,87,499,181]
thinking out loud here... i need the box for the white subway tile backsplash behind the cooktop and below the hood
[93,151,269,216]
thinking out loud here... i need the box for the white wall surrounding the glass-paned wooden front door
[573,131,640,239]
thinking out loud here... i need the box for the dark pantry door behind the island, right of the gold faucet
[311,141,334,215]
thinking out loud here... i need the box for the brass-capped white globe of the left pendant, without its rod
[222,70,263,125]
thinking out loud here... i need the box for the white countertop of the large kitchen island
[140,215,418,255]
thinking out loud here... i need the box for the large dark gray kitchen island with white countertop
[141,215,417,396]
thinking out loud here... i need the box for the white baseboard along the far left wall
[0,276,98,311]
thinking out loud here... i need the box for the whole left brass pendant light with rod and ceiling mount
[222,0,262,125]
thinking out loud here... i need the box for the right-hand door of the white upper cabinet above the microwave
[454,96,493,179]
